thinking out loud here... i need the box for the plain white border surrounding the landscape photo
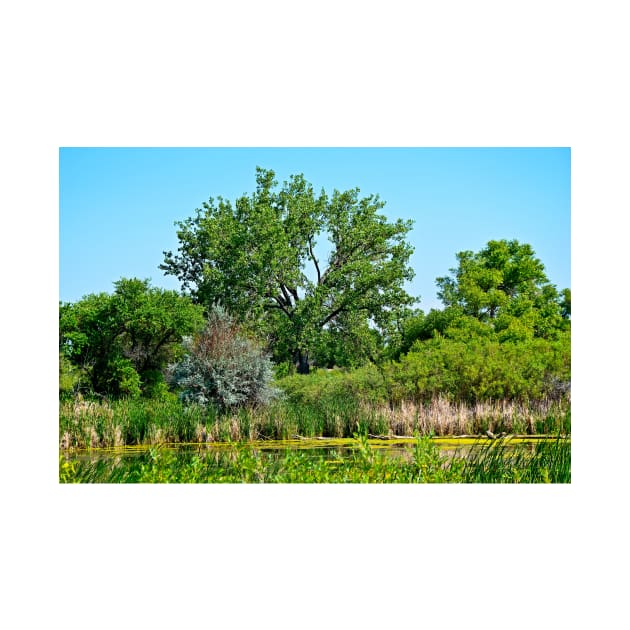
[0,0,630,629]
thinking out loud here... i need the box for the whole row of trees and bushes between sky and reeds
[59,169,571,410]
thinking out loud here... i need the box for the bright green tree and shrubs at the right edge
[384,241,571,403]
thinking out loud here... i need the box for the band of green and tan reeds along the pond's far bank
[59,395,571,449]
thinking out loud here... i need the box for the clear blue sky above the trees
[59,148,571,311]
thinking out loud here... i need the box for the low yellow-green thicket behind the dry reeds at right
[278,333,571,405]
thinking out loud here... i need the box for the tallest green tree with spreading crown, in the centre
[160,168,415,373]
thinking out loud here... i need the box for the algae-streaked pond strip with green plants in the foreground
[59,436,571,483]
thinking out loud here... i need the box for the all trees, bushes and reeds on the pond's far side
[59,169,571,484]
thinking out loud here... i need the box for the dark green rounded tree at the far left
[59,278,203,396]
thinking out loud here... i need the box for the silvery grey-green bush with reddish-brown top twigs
[168,306,277,410]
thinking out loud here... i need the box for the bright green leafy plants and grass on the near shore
[59,434,571,483]
